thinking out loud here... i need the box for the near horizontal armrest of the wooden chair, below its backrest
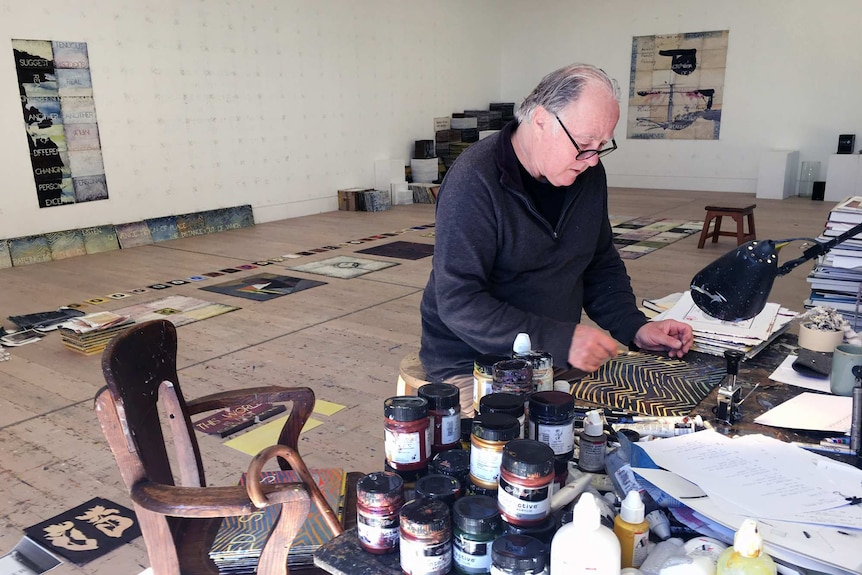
[131,481,309,519]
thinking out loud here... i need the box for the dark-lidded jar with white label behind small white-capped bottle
[527,391,575,485]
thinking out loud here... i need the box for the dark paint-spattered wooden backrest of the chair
[102,320,206,488]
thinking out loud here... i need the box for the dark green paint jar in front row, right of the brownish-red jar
[452,495,503,575]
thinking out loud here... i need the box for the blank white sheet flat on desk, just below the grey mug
[754,391,853,434]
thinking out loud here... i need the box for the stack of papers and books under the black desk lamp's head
[641,292,797,359]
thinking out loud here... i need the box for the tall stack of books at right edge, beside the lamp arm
[805,196,862,330]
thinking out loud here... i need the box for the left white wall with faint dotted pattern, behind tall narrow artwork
[0,0,500,238]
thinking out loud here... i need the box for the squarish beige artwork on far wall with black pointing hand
[627,30,728,140]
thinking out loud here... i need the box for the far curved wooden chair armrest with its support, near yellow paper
[186,385,314,454]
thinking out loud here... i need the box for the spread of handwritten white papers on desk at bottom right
[634,430,862,575]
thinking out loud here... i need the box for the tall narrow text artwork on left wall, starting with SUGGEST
[12,40,108,208]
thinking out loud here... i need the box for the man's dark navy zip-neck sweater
[419,122,646,381]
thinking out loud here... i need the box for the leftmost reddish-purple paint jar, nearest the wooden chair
[356,471,404,555]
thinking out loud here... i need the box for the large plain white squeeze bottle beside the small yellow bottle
[551,492,620,575]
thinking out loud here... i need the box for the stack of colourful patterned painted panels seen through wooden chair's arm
[209,468,347,575]
